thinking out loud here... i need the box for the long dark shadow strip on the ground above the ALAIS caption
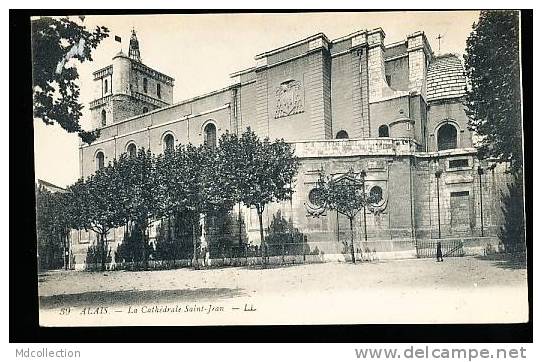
[40,288,245,309]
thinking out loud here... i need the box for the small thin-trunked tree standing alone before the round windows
[313,170,370,264]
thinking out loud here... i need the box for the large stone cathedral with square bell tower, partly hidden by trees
[73,28,507,264]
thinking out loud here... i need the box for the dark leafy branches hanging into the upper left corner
[31,17,109,143]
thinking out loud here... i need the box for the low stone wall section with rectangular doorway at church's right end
[413,152,506,239]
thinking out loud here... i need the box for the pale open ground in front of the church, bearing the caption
[39,257,528,325]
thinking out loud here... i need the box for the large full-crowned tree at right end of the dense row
[220,128,299,262]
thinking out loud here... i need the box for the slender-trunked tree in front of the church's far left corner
[68,160,127,271]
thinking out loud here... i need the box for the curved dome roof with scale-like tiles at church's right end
[427,54,467,101]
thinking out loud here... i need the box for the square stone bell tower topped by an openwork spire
[89,29,175,129]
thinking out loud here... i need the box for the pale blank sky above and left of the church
[34,11,479,187]
